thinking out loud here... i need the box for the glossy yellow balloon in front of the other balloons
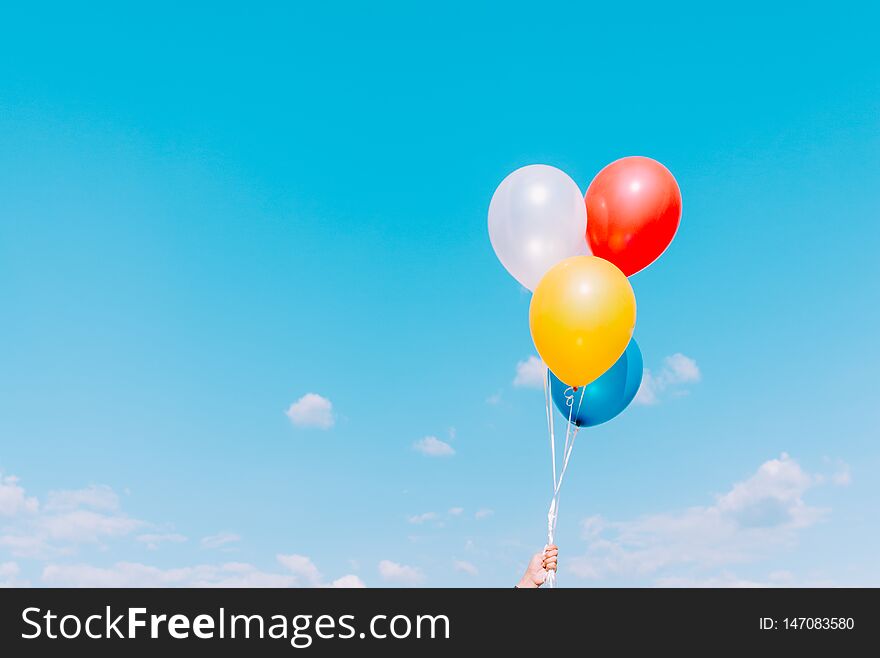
[529,256,636,386]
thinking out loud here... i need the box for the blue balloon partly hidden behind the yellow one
[550,338,644,427]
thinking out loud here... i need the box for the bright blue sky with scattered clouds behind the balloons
[0,2,880,586]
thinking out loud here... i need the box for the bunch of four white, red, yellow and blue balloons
[489,156,681,427]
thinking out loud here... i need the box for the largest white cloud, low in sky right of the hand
[570,453,827,583]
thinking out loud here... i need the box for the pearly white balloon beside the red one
[489,165,590,291]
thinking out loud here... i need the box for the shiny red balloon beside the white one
[586,156,681,276]
